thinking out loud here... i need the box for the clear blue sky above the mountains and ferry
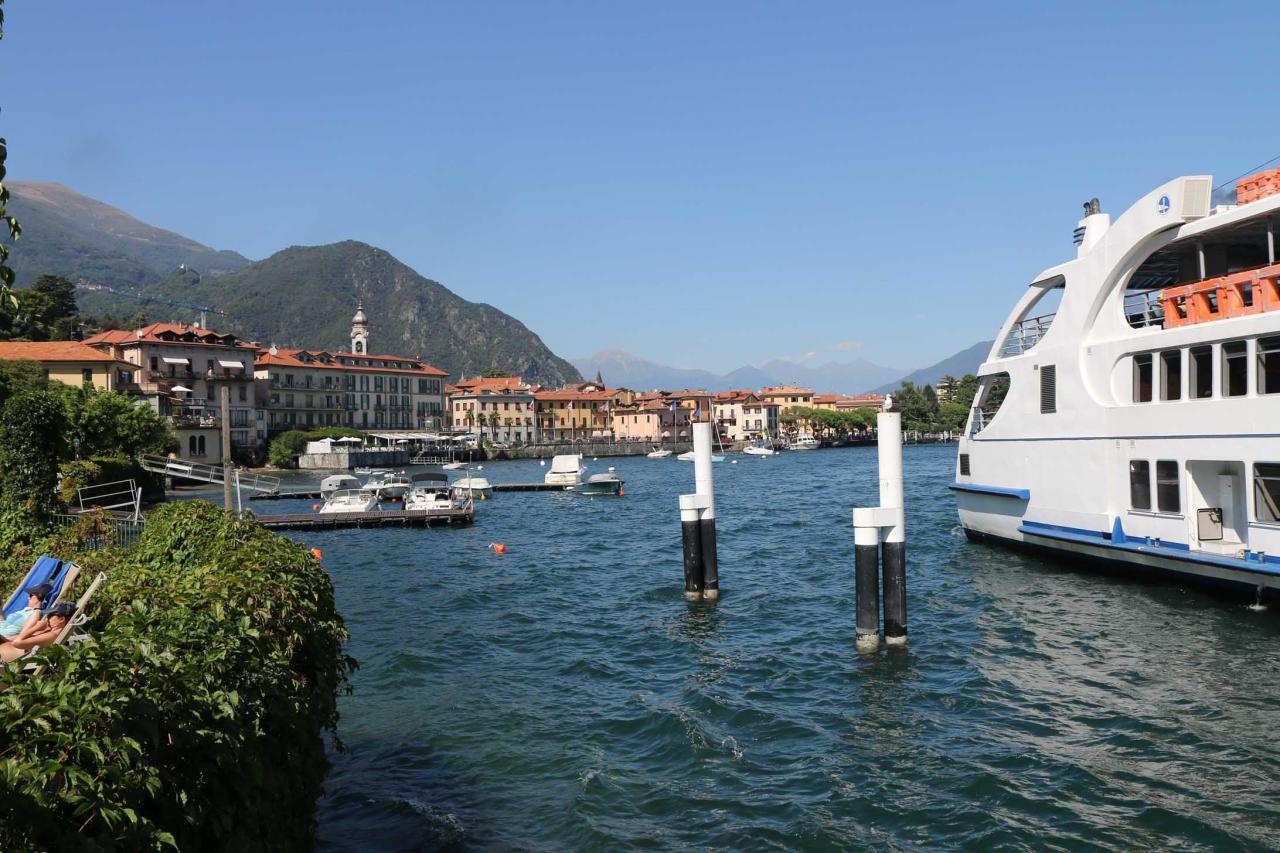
[0,0,1280,370]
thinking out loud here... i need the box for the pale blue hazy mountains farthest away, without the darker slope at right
[572,350,902,394]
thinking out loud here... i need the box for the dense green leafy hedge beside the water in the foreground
[0,501,355,850]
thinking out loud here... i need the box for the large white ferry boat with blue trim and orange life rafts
[951,170,1280,599]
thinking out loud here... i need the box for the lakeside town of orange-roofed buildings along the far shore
[0,294,973,466]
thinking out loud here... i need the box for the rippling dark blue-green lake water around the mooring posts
[255,446,1280,850]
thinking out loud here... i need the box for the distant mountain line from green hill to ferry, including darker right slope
[572,341,991,394]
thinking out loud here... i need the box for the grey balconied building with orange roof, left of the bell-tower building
[84,323,259,465]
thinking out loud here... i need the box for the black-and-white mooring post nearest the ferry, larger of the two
[854,397,906,652]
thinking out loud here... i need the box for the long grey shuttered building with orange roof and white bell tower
[253,306,448,433]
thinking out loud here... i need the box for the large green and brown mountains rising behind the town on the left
[6,181,581,386]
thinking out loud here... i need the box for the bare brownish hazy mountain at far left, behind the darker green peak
[5,181,250,289]
